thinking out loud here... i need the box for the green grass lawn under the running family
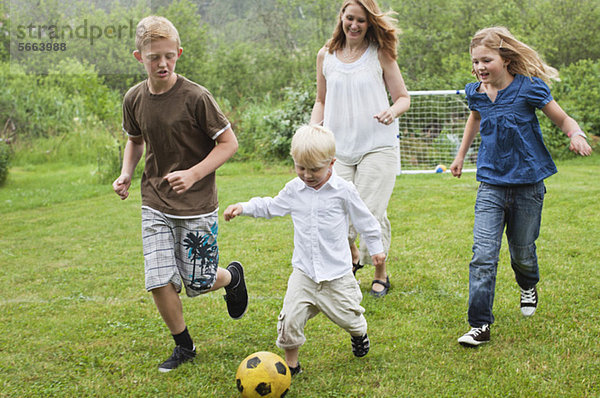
[0,155,600,397]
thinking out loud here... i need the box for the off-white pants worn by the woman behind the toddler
[334,148,398,264]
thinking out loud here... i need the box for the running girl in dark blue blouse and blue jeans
[450,27,592,346]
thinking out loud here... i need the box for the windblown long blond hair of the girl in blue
[469,26,558,84]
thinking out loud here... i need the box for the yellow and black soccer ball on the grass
[235,351,292,398]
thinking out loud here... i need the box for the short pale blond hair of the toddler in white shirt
[290,125,335,168]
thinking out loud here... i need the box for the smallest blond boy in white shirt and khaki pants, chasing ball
[223,126,385,375]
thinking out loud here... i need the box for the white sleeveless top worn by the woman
[323,44,398,165]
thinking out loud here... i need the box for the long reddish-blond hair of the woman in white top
[325,0,399,59]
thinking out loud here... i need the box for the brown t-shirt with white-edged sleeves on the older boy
[123,76,229,217]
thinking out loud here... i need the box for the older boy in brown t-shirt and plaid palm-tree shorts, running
[113,16,248,372]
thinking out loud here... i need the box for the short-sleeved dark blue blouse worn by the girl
[465,74,557,186]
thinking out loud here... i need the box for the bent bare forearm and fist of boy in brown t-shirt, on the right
[164,128,238,194]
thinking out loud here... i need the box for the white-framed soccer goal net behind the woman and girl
[398,90,480,174]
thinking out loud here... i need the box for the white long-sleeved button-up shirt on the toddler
[242,173,383,283]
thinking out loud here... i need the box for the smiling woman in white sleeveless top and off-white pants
[311,0,410,297]
